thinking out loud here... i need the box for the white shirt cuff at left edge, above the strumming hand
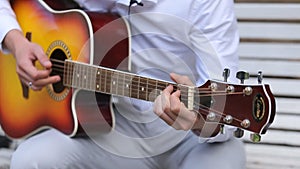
[0,0,21,52]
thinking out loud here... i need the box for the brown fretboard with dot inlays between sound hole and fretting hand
[63,60,177,101]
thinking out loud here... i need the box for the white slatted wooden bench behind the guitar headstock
[235,0,300,169]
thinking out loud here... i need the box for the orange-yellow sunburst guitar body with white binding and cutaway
[0,0,129,138]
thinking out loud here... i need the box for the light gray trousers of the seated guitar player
[11,102,246,169]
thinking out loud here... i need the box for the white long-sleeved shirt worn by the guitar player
[0,0,239,147]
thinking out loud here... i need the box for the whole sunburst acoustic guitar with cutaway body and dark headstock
[0,0,275,138]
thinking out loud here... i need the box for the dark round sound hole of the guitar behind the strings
[50,49,67,93]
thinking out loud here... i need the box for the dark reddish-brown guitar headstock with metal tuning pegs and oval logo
[194,69,275,142]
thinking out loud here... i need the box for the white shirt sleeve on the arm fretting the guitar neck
[190,0,239,142]
